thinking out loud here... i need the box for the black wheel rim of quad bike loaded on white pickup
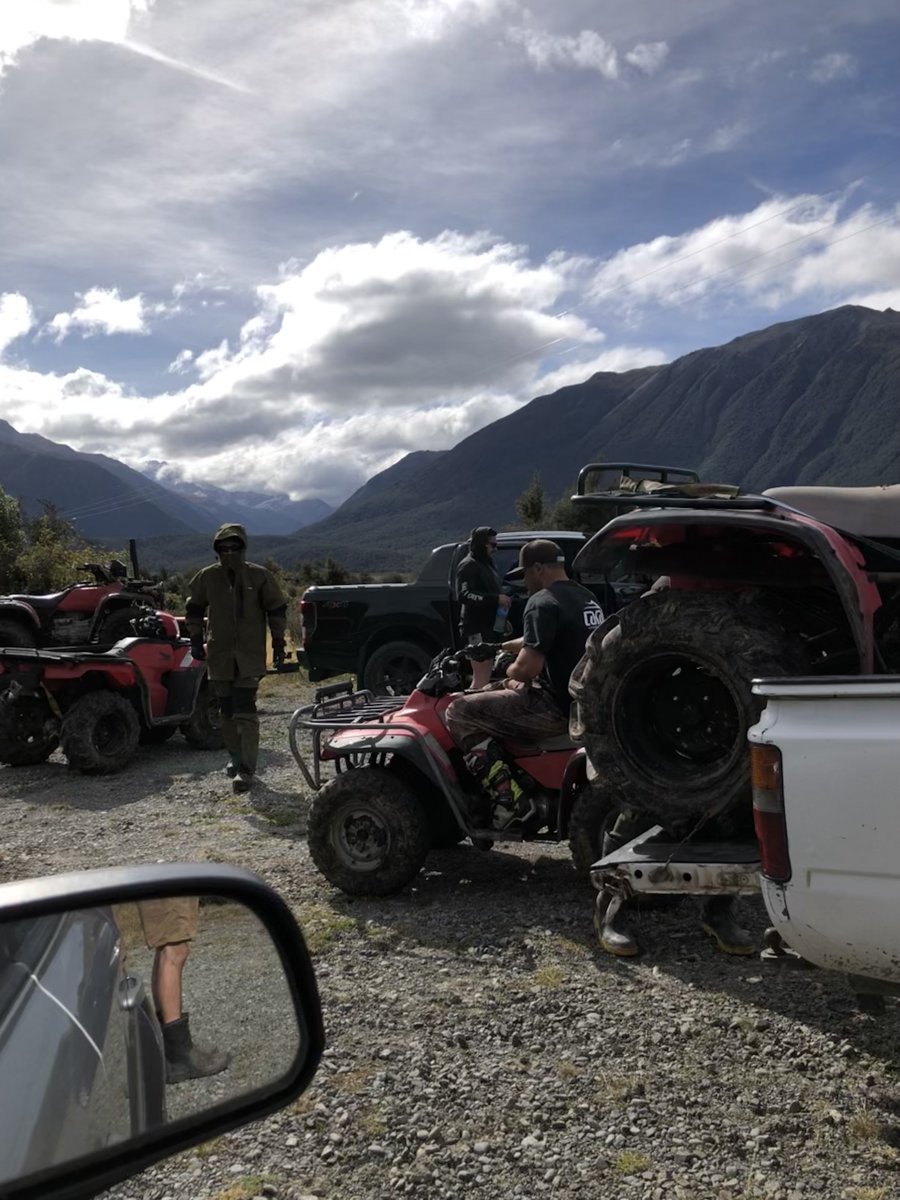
[616,654,744,779]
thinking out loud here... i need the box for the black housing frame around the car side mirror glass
[0,864,324,1200]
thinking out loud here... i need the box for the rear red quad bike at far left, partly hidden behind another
[0,540,163,647]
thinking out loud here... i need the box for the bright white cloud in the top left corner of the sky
[0,0,154,76]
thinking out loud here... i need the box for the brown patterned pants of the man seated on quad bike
[444,684,569,751]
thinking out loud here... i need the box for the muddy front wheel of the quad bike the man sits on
[307,767,431,896]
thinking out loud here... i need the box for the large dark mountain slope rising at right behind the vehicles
[272,306,900,570]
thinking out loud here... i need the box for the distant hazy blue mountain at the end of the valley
[142,461,332,534]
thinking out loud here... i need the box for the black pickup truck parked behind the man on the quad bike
[300,529,619,695]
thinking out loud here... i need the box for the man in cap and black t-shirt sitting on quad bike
[445,538,604,829]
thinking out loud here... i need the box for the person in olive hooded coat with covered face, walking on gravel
[185,524,287,792]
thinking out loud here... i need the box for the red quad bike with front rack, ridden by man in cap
[288,648,608,895]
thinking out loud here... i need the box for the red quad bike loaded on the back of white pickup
[572,463,900,916]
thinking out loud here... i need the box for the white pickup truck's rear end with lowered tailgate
[592,676,900,994]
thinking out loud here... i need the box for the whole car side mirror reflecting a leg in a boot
[0,864,324,1200]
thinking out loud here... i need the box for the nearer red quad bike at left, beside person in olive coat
[0,613,223,775]
